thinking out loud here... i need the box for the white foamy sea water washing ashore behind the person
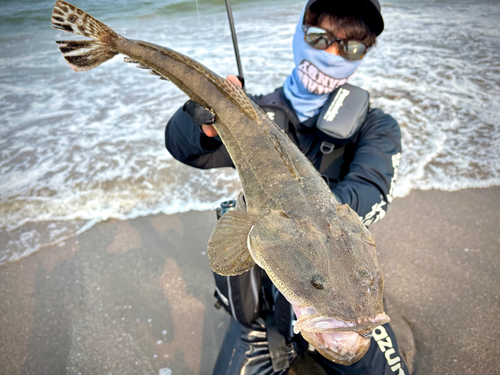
[0,0,500,264]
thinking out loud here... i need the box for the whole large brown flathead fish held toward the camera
[51,1,389,365]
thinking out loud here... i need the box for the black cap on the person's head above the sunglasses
[307,0,384,36]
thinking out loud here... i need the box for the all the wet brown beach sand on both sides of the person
[0,187,500,375]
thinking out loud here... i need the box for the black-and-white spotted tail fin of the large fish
[51,1,121,71]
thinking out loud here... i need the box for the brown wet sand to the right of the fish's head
[370,187,500,374]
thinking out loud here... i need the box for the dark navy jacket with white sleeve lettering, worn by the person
[165,89,401,225]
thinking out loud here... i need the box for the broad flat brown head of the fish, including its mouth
[248,205,389,365]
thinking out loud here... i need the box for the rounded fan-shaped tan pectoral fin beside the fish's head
[207,210,258,276]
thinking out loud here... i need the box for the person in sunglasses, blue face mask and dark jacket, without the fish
[166,0,408,374]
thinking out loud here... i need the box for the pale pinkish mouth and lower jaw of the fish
[292,305,390,366]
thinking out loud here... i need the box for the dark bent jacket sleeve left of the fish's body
[165,107,234,169]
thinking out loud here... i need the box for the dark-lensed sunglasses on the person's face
[302,25,368,61]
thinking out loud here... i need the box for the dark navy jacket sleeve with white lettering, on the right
[332,109,401,226]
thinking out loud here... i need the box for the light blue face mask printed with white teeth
[283,1,361,122]
